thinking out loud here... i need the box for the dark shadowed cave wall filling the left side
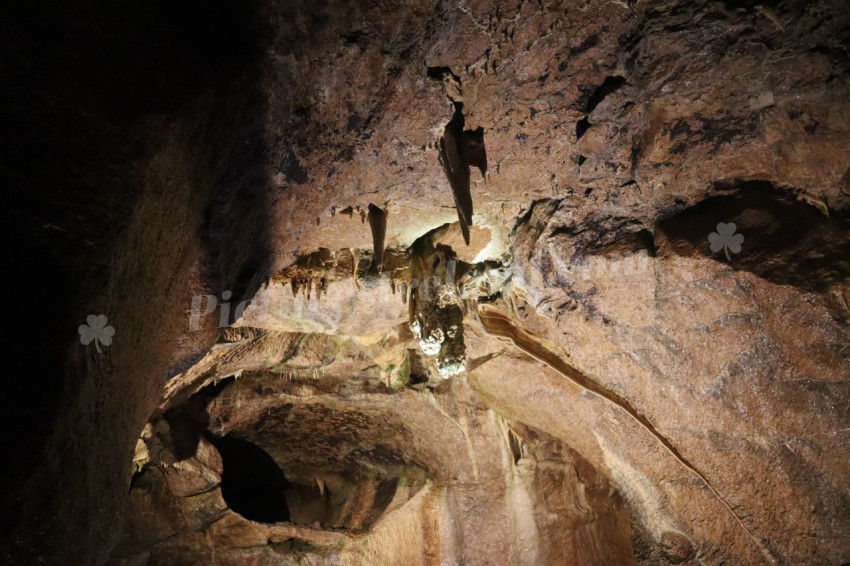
[0,2,264,564]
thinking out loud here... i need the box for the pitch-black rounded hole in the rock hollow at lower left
[213,436,290,523]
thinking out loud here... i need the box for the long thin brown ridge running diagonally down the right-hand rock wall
[478,305,777,564]
